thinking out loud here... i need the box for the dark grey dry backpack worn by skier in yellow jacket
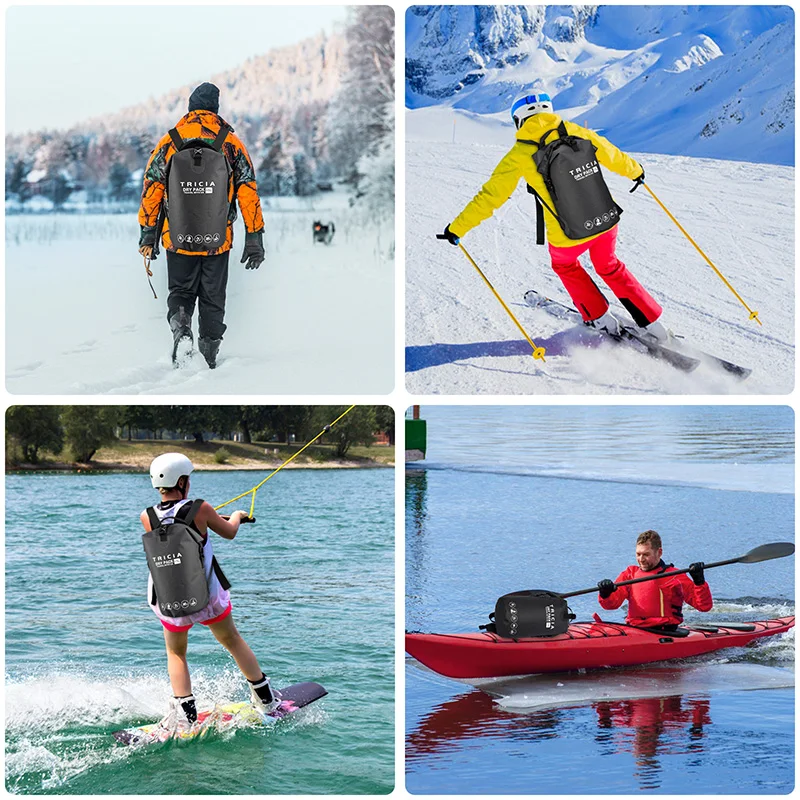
[520,121,622,244]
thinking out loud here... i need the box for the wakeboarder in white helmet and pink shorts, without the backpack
[140,453,279,732]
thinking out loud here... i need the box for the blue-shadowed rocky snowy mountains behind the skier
[406,5,794,164]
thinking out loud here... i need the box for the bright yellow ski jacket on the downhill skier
[450,114,643,247]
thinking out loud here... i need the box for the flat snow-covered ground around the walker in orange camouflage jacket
[6,194,394,395]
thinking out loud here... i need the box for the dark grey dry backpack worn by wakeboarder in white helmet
[142,500,230,617]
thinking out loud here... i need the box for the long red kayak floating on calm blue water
[406,617,794,679]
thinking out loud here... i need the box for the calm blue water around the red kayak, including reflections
[406,406,795,794]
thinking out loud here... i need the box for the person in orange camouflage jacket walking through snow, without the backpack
[139,83,264,369]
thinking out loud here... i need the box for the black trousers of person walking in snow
[167,250,230,339]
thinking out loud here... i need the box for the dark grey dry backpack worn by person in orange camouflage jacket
[167,123,233,253]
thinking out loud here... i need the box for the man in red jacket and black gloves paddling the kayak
[597,530,714,630]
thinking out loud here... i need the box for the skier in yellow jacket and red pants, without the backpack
[444,94,669,342]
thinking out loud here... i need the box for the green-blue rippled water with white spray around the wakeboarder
[6,469,394,794]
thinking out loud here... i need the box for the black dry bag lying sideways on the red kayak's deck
[489,589,575,639]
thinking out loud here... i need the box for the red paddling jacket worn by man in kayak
[599,561,714,628]
